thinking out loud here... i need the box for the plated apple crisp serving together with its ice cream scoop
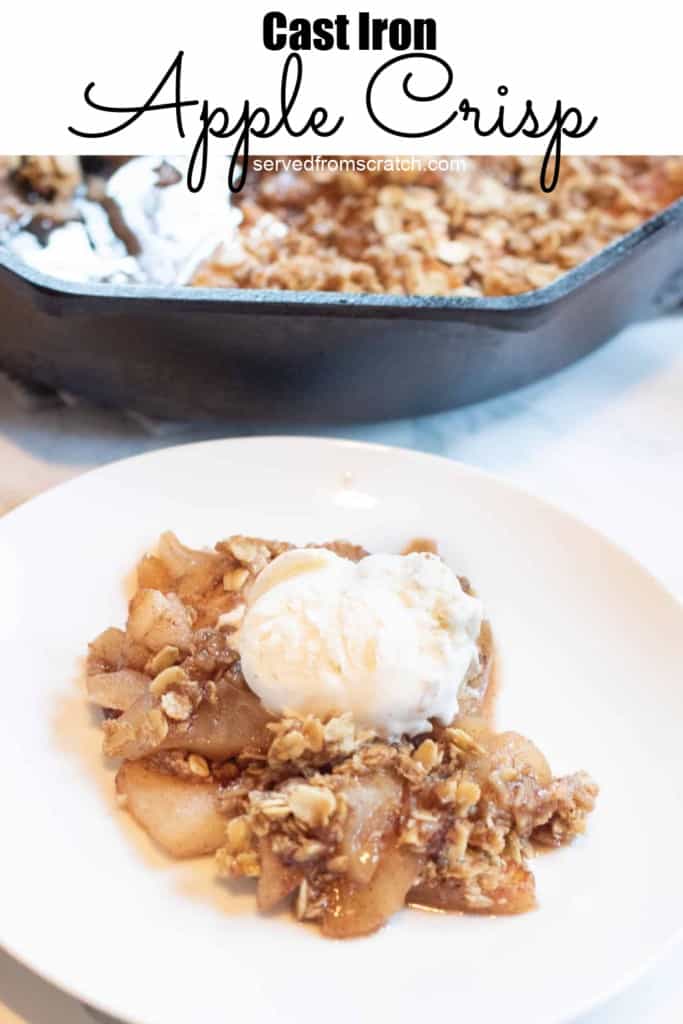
[87,534,597,938]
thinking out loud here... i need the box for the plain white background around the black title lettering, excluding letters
[0,0,683,154]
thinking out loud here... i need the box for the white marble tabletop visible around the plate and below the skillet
[0,316,683,1024]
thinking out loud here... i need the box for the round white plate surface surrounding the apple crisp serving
[0,438,683,1024]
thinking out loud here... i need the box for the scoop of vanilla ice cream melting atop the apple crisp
[239,548,482,738]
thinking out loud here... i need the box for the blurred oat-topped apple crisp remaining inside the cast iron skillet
[193,157,683,296]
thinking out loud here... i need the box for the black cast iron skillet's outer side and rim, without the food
[0,200,683,424]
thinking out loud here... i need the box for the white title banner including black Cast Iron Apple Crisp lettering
[0,0,683,186]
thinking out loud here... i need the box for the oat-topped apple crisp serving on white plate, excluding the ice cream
[87,534,598,938]
